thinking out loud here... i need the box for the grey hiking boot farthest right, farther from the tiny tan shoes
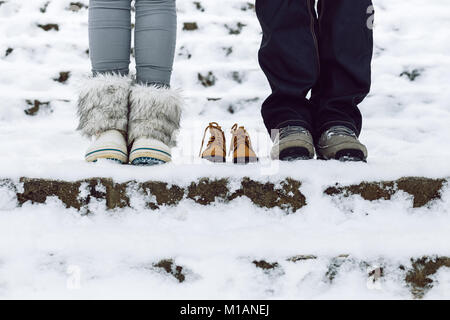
[316,126,367,162]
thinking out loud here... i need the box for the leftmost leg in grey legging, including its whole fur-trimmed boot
[78,0,131,163]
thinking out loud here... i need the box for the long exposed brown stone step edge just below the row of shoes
[0,177,448,213]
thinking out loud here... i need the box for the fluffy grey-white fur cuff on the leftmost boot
[77,74,131,137]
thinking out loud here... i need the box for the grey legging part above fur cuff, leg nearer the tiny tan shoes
[135,0,177,86]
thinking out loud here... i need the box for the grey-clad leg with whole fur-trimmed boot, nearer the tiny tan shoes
[128,0,182,165]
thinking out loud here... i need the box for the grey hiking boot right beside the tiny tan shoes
[270,126,314,161]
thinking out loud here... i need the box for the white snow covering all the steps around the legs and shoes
[0,0,450,298]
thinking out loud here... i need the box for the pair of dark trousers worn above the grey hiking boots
[256,0,373,137]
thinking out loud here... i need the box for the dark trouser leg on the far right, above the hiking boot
[312,0,373,137]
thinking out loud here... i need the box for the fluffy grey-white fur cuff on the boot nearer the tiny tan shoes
[128,85,183,147]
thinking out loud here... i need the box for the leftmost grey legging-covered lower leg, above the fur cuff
[89,0,131,75]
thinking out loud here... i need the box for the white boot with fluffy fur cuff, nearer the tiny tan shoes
[128,84,182,165]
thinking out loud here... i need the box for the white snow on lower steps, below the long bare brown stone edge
[0,189,450,299]
